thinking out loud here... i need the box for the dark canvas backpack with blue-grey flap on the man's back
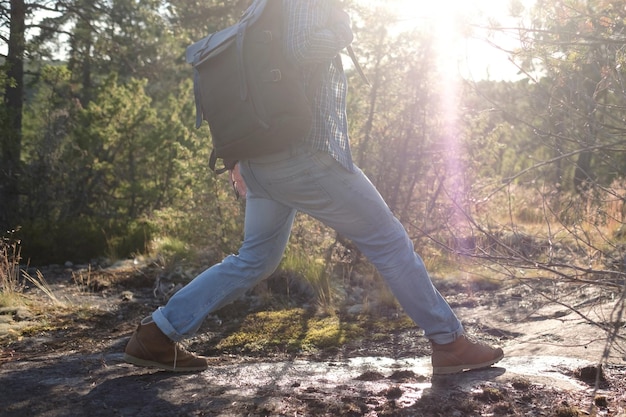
[187,0,362,173]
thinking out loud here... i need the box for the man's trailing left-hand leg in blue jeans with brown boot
[125,192,295,371]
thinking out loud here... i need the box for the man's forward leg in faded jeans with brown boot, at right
[242,151,502,373]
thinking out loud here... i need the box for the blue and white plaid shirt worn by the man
[283,0,354,171]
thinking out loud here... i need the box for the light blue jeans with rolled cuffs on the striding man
[152,147,463,343]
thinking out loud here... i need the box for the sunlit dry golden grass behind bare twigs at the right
[437,181,626,279]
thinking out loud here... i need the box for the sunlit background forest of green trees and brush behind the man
[0,0,626,354]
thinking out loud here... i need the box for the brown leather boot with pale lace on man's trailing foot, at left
[124,317,208,372]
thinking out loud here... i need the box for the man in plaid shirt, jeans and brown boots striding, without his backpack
[125,0,504,374]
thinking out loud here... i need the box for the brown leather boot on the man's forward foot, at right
[431,336,504,375]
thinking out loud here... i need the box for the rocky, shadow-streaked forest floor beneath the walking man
[0,263,626,417]
